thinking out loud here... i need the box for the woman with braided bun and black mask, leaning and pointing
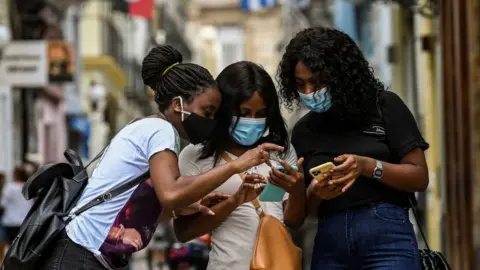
[39,46,282,270]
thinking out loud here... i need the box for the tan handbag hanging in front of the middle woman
[222,152,302,270]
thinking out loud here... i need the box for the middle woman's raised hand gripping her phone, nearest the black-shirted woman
[268,158,305,193]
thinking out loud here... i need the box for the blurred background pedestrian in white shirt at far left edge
[0,166,32,245]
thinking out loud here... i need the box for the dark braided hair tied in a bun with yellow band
[142,45,217,112]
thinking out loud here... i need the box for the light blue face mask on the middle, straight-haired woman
[229,116,267,146]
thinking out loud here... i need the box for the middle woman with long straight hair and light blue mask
[175,61,306,270]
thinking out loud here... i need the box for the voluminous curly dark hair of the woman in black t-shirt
[277,27,385,120]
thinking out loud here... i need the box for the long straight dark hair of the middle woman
[200,61,290,161]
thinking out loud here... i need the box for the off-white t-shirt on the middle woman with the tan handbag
[179,145,297,270]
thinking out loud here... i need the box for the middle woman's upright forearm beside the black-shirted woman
[284,187,307,228]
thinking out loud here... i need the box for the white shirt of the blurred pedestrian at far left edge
[1,182,33,227]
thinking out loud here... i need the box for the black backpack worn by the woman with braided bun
[1,119,150,270]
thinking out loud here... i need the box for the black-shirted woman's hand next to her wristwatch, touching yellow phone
[328,154,365,192]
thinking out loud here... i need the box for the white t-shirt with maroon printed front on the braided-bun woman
[67,118,180,269]
